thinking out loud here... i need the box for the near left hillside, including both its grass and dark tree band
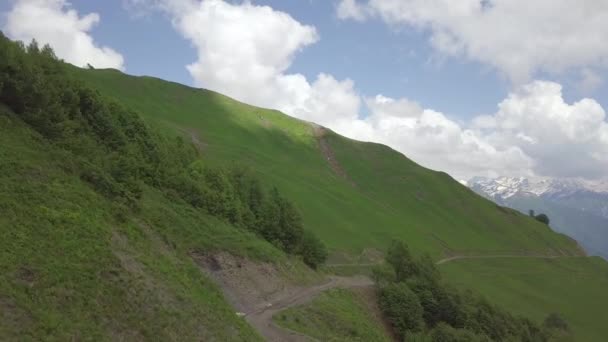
[0,33,322,341]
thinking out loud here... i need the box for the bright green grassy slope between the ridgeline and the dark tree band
[74,69,578,256]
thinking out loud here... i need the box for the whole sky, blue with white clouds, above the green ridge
[0,0,608,179]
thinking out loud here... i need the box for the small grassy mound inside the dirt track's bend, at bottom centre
[273,289,391,342]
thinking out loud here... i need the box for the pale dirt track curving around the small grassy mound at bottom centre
[245,276,374,342]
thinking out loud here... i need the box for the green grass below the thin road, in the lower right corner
[440,258,608,342]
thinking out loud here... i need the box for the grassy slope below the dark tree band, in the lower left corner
[0,107,286,341]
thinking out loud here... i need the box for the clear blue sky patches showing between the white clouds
[0,0,528,119]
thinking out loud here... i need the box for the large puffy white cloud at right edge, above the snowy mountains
[477,81,608,178]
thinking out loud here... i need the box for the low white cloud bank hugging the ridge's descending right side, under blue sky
[333,95,532,178]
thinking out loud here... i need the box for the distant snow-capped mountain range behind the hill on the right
[466,177,608,259]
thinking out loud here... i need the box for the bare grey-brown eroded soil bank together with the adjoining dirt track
[192,253,373,342]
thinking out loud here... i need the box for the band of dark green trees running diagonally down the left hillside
[0,33,327,267]
